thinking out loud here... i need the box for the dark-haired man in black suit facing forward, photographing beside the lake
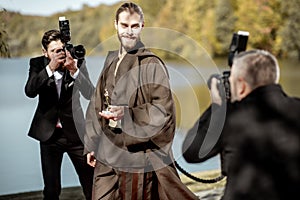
[25,30,94,200]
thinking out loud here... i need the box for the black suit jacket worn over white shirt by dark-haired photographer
[25,56,94,143]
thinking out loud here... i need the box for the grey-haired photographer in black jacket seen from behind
[183,50,300,200]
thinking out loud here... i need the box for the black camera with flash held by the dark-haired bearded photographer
[59,17,85,61]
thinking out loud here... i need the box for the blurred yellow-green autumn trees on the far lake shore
[0,0,300,60]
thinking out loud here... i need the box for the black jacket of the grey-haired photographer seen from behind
[183,85,300,200]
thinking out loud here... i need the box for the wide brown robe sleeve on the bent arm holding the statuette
[122,57,176,155]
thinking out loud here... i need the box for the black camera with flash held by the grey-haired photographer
[208,31,249,100]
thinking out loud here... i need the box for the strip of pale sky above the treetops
[0,0,121,16]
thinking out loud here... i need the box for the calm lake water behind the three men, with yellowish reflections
[0,57,300,195]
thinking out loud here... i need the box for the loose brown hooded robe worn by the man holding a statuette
[85,42,198,200]
